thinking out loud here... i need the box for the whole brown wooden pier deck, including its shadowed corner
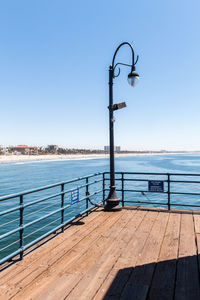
[0,207,200,300]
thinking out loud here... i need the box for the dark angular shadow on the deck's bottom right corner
[103,255,200,300]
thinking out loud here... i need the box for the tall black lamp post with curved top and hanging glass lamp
[104,42,139,210]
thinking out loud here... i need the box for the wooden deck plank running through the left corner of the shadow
[94,212,158,300]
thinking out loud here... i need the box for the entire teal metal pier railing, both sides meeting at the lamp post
[0,172,200,264]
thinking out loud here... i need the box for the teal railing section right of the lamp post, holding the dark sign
[104,172,200,210]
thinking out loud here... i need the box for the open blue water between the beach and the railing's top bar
[0,155,200,197]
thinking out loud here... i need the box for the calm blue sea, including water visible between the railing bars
[0,154,200,259]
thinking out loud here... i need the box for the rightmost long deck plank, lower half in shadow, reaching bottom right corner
[175,214,200,300]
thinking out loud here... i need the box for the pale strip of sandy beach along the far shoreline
[0,152,194,163]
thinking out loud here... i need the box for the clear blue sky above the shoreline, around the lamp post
[0,0,200,150]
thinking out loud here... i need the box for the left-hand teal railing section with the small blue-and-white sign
[0,173,103,264]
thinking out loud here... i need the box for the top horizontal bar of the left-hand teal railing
[0,172,103,201]
